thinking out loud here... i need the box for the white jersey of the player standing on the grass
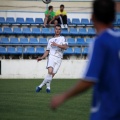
[47,36,68,58]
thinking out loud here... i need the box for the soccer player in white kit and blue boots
[36,25,68,93]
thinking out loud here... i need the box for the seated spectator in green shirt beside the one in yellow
[44,6,58,27]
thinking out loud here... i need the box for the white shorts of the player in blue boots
[47,55,62,73]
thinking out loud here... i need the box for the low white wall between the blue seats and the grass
[0,60,87,79]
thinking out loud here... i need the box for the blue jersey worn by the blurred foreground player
[84,29,120,120]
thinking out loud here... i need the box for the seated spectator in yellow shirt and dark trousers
[56,5,67,28]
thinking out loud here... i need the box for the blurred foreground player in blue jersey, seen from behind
[51,0,120,120]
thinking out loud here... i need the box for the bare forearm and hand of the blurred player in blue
[51,79,94,109]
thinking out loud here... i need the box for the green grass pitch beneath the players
[0,79,92,120]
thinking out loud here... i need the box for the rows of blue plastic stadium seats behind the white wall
[0,17,120,59]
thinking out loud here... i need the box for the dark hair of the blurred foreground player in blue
[93,0,116,24]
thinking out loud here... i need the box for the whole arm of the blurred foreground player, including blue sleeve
[51,39,107,109]
